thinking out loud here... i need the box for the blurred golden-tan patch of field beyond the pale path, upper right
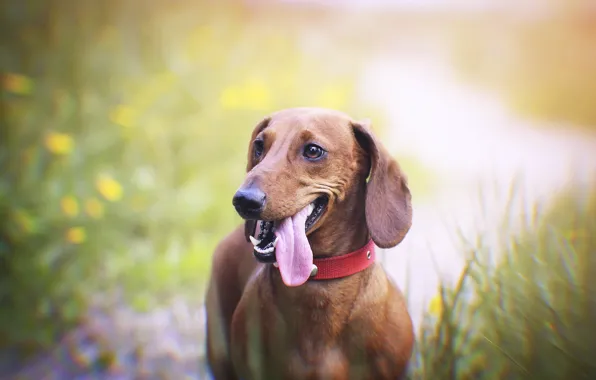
[453,7,596,129]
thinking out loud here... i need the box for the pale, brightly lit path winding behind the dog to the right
[362,54,596,330]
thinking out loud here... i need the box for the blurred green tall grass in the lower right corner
[410,184,596,380]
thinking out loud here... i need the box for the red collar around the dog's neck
[309,239,375,280]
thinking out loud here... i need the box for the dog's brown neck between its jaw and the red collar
[308,179,370,257]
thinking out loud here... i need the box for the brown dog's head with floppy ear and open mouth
[233,108,412,284]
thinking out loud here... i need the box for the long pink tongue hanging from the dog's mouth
[275,207,312,286]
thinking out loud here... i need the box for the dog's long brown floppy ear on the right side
[352,120,412,248]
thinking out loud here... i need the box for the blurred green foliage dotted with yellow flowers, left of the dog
[0,0,374,347]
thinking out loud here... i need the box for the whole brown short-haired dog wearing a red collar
[206,108,414,380]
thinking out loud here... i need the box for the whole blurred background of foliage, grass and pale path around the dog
[0,0,596,379]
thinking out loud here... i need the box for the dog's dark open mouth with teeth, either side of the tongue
[249,195,329,263]
